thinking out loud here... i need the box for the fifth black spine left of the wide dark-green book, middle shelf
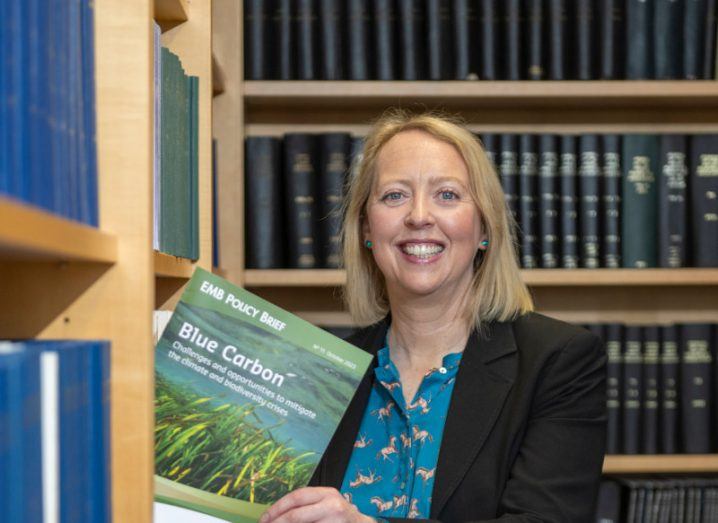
[519,134,539,269]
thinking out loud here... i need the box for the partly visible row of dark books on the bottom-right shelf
[596,477,718,523]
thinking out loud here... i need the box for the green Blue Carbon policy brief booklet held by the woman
[155,268,372,523]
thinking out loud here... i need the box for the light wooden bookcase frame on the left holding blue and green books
[0,0,212,523]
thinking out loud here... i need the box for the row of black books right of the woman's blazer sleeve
[588,323,718,454]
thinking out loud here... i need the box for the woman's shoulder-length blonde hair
[342,110,534,328]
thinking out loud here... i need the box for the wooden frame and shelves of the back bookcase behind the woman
[213,0,718,486]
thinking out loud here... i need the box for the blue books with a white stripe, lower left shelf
[0,340,112,523]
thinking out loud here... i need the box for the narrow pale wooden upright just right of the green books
[162,1,212,270]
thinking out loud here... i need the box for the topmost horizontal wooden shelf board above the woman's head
[243,81,718,110]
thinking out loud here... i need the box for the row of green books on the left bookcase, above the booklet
[153,23,199,260]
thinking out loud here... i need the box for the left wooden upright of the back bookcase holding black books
[212,0,244,285]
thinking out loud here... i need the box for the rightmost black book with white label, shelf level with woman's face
[688,134,718,267]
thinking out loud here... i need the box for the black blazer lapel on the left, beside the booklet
[322,319,388,490]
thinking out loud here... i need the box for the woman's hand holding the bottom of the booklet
[259,487,376,523]
